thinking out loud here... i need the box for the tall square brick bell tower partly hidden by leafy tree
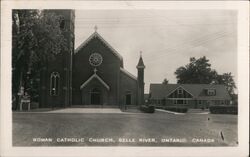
[39,9,75,108]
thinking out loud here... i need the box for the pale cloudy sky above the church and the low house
[75,10,237,93]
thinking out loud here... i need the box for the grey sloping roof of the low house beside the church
[150,84,230,100]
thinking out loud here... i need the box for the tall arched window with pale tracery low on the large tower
[50,72,60,96]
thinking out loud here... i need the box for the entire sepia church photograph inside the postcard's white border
[1,1,249,157]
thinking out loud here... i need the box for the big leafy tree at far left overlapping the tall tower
[12,10,66,108]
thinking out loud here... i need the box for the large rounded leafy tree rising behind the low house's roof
[175,56,217,84]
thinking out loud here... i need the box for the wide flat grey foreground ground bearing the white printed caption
[13,111,237,146]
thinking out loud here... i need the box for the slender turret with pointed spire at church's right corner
[136,52,145,106]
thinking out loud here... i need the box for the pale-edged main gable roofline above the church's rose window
[75,31,123,61]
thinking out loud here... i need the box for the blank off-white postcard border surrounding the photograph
[0,1,249,157]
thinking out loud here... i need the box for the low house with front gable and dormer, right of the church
[148,84,231,108]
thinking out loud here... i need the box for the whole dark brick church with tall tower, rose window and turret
[40,10,145,108]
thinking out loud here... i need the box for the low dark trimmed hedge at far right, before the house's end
[209,106,238,114]
